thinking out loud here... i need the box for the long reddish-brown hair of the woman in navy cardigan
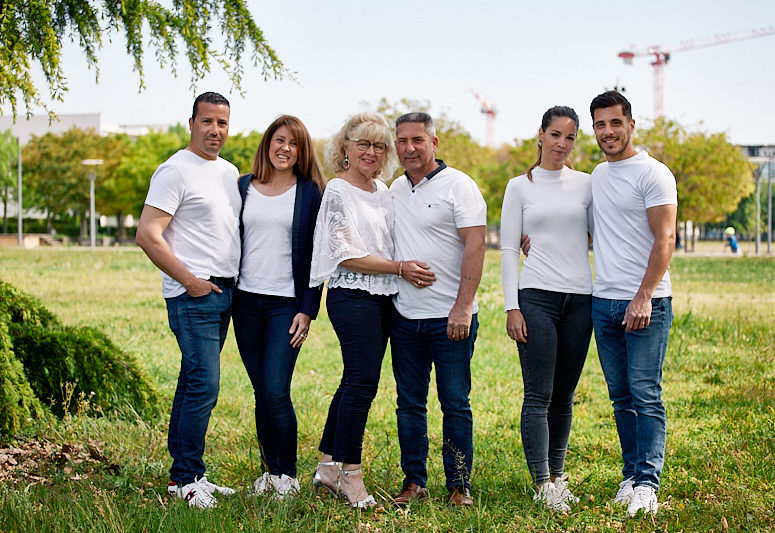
[253,115,326,192]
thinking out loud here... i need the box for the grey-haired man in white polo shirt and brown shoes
[390,113,487,506]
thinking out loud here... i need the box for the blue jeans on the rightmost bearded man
[592,297,673,490]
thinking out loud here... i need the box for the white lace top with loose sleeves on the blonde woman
[309,178,398,295]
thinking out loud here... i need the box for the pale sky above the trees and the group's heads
[22,0,775,144]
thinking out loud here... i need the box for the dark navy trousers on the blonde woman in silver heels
[320,288,393,464]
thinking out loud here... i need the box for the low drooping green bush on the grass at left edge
[0,281,158,434]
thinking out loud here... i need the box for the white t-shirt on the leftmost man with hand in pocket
[145,150,242,298]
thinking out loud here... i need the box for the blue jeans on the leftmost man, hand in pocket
[166,286,232,485]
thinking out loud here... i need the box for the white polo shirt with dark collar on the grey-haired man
[390,167,487,319]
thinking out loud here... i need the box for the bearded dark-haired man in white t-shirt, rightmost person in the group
[590,91,678,516]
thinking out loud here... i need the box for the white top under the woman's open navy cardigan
[237,183,296,298]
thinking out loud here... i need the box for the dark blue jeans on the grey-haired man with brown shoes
[390,309,479,489]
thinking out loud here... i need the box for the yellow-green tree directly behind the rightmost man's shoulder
[636,119,754,248]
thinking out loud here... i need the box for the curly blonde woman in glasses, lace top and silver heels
[310,113,435,508]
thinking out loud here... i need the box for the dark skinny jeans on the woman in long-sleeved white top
[517,289,592,485]
